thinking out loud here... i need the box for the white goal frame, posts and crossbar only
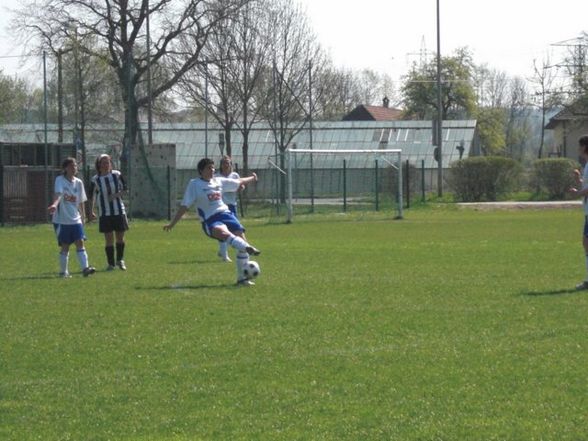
[285,149,404,223]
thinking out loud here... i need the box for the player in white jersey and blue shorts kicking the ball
[163,158,260,286]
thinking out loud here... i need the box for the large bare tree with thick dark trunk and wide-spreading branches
[14,0,249,171]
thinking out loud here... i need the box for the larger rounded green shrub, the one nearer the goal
[447,156,522,202]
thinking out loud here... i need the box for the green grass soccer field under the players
[0,208,588,441]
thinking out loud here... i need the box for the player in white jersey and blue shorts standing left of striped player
[47,158,96,278]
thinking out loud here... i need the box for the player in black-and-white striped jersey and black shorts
[90,155,129,271]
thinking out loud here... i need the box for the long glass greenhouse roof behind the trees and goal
[0,120,477,169]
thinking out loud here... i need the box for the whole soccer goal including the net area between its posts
[282,149,403,222]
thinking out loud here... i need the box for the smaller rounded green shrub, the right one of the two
[531,158,577,199]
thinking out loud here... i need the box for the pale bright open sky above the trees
[0,0,588,84]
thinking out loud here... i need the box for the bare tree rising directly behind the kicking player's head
[179,0,272,173]
